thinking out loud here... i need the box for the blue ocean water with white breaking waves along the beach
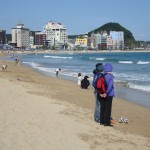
[4,52,150,107]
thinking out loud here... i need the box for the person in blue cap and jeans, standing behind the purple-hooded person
[92,63,104,123]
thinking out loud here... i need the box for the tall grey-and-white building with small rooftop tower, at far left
[12,23,30,49]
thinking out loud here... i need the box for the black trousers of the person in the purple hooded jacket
[100,97,113,125]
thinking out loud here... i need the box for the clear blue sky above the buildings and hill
[0,0,150,41]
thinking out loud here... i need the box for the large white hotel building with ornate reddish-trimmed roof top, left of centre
[43,21,67,49]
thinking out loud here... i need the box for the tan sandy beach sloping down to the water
[0,60,150,150]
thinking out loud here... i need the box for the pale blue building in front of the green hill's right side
[110,31,124,49]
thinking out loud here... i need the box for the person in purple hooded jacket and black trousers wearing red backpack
[98,63,115,126]
